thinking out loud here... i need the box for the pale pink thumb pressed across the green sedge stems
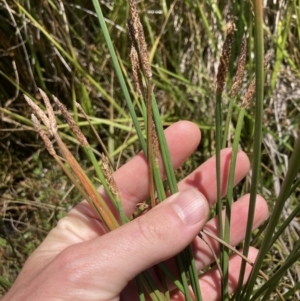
[73,189,209,297]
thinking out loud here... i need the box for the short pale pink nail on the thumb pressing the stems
[172,189,208,226]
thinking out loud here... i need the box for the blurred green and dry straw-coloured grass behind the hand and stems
[0,0,300,300]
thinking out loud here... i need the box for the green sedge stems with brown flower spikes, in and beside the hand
[0,0,300,300]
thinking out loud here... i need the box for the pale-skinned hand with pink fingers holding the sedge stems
[2,121,268,301]
